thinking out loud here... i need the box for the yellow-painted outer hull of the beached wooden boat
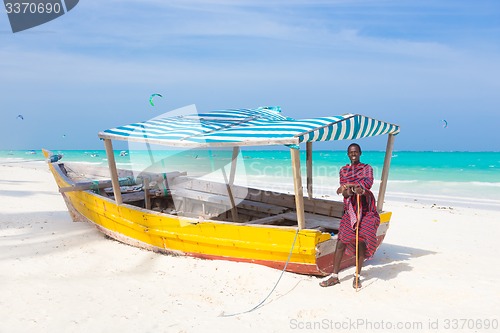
[44,150,391,276]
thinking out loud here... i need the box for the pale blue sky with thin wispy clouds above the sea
[0,0,500,151]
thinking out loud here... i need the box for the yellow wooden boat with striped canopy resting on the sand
[44,107,399,276]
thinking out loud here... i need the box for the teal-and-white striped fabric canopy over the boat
[99,107,399,147]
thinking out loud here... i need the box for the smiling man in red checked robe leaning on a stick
[320,143,380,288]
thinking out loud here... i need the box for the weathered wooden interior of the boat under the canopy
[62,166,343,232]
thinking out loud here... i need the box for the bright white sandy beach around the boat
[0,162,500,333]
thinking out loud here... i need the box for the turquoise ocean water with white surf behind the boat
[0,149,500,210]
